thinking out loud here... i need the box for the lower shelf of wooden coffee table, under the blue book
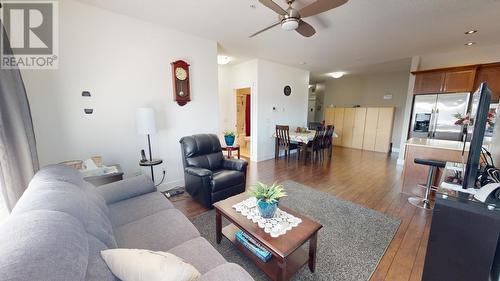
[222,224,309,280]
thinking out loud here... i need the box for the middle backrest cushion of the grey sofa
[12,181,116,248]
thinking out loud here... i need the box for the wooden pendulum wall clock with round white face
[171,60,191,106]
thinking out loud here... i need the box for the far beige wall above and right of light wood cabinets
[324,71,409,151]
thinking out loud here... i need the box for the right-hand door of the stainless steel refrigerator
[433,93,469,141]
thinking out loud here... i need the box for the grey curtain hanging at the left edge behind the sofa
[0,22,38,211]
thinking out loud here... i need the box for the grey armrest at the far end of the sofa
[97,175,156,205]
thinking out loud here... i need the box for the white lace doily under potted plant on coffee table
[233,197,302,238]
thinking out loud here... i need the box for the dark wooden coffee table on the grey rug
[214,194,323,281]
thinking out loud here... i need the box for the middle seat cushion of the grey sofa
[114,209,200,249]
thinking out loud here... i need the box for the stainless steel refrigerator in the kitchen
[410,93,470,141]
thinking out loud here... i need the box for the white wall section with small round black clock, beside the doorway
[219,59,309,161]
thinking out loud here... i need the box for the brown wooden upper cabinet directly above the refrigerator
[412,66,477,94]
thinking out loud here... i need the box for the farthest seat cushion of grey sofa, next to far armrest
[108,192,174,227]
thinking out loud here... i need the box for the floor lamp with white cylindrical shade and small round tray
[136,107,161,182]
